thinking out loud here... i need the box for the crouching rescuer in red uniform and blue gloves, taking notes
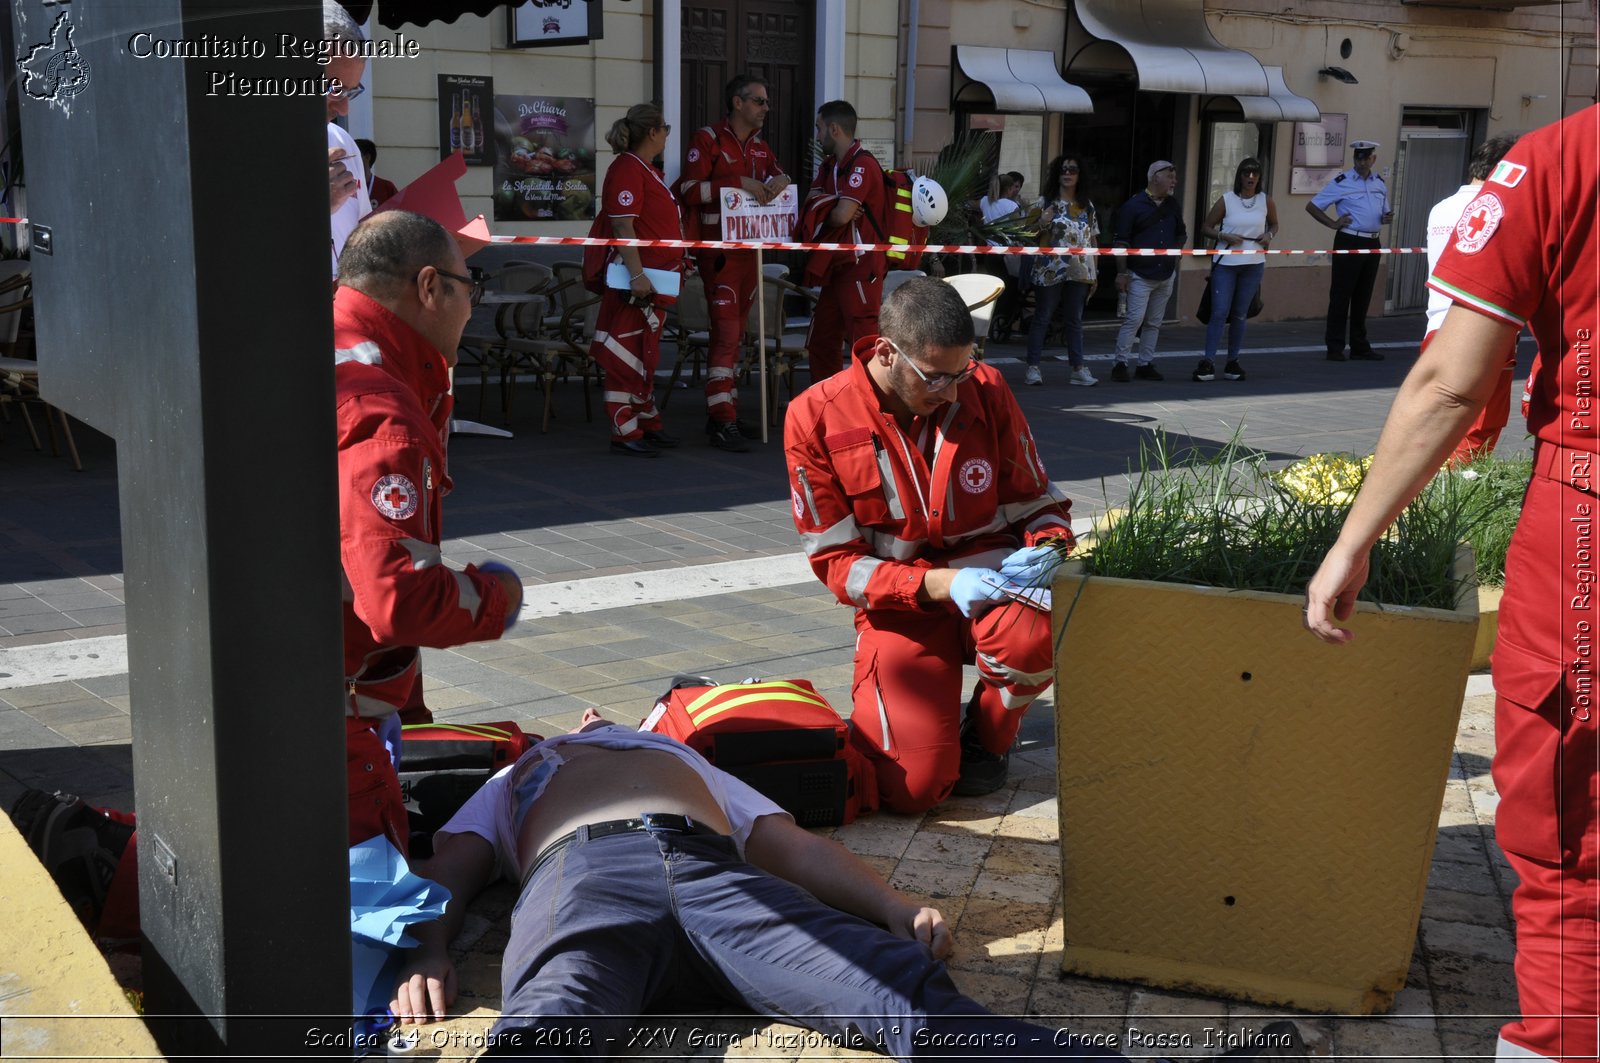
[784,279,1072,812]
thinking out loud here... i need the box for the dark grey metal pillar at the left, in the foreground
[11,0,350,1055]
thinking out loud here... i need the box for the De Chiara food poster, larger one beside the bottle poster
[491,96,600,221]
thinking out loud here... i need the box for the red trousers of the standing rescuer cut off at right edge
[1493,464,1600,1060]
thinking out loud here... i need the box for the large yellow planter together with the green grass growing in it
[1053,434,1477,1013]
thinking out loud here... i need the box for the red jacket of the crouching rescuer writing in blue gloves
[784,341,1072,610]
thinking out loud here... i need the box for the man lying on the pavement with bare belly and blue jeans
[390,709,1299,1058]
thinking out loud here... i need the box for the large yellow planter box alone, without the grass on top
[1054,564,1477,1013]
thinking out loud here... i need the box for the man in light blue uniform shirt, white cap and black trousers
[1306,141,1394,362]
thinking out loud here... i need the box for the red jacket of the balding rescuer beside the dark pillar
[333,288,507,716]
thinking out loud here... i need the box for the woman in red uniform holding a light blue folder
[589,104,683,458]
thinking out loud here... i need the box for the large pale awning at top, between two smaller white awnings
[1067,0,1272,96]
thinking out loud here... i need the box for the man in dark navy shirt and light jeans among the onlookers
[1110,158,1189,381]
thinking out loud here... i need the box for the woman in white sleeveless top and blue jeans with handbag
[1194,158,1278,381]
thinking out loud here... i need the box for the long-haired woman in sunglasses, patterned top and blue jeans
[1022,154,1099,387]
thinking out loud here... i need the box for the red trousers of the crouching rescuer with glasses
[850,602,1053,812]
